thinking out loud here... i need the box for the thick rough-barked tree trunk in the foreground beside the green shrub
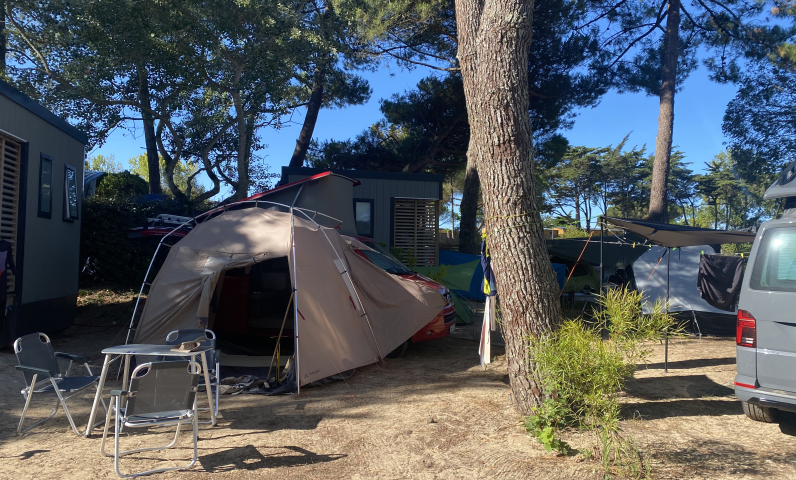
[456,0,561,415]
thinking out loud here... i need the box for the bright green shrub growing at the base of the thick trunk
[525,288,682,472]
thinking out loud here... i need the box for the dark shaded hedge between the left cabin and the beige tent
[80,195,188,287]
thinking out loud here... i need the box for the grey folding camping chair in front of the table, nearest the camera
[100,361,202,478]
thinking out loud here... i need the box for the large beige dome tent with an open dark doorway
[129,201,445,388]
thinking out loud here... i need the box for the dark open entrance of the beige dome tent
[209,257,295,360]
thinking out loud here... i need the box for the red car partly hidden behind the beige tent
[344,236,456,358]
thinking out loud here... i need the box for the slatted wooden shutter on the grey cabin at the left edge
[0,135,22,305]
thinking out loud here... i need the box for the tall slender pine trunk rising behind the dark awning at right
[647,0,680,222]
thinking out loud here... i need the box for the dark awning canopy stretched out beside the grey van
[603,217,755,247]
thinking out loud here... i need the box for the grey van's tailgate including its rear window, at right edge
[740,222,796,392]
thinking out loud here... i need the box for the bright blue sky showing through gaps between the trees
[89,58,736,197]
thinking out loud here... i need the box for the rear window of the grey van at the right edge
[749,228,796,292]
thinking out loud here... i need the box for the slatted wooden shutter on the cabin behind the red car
[393,198,439,267]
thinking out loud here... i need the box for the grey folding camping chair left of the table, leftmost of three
[14,333,107,435]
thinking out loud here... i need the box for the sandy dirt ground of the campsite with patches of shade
[0,292,796,479]
